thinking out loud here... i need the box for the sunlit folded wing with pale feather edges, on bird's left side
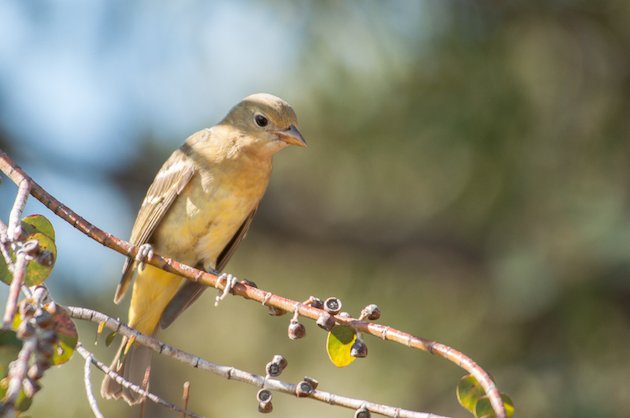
[114,150,195,303]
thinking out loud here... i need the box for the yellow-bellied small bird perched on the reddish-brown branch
[101,93,306,405]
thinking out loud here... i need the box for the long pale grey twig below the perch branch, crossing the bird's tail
[66,306,445,418]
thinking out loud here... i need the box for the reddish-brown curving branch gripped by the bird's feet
[0,150,507,418]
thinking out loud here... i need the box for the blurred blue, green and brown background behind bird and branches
[0,0,630,417]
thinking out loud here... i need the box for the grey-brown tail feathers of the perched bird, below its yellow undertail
[101,338,151,405]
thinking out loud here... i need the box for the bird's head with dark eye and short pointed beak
[221,93,306,153]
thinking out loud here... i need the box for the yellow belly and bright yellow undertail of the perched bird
[129,162,267,335]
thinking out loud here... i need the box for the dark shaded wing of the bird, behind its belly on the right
[160,208,257,328]
